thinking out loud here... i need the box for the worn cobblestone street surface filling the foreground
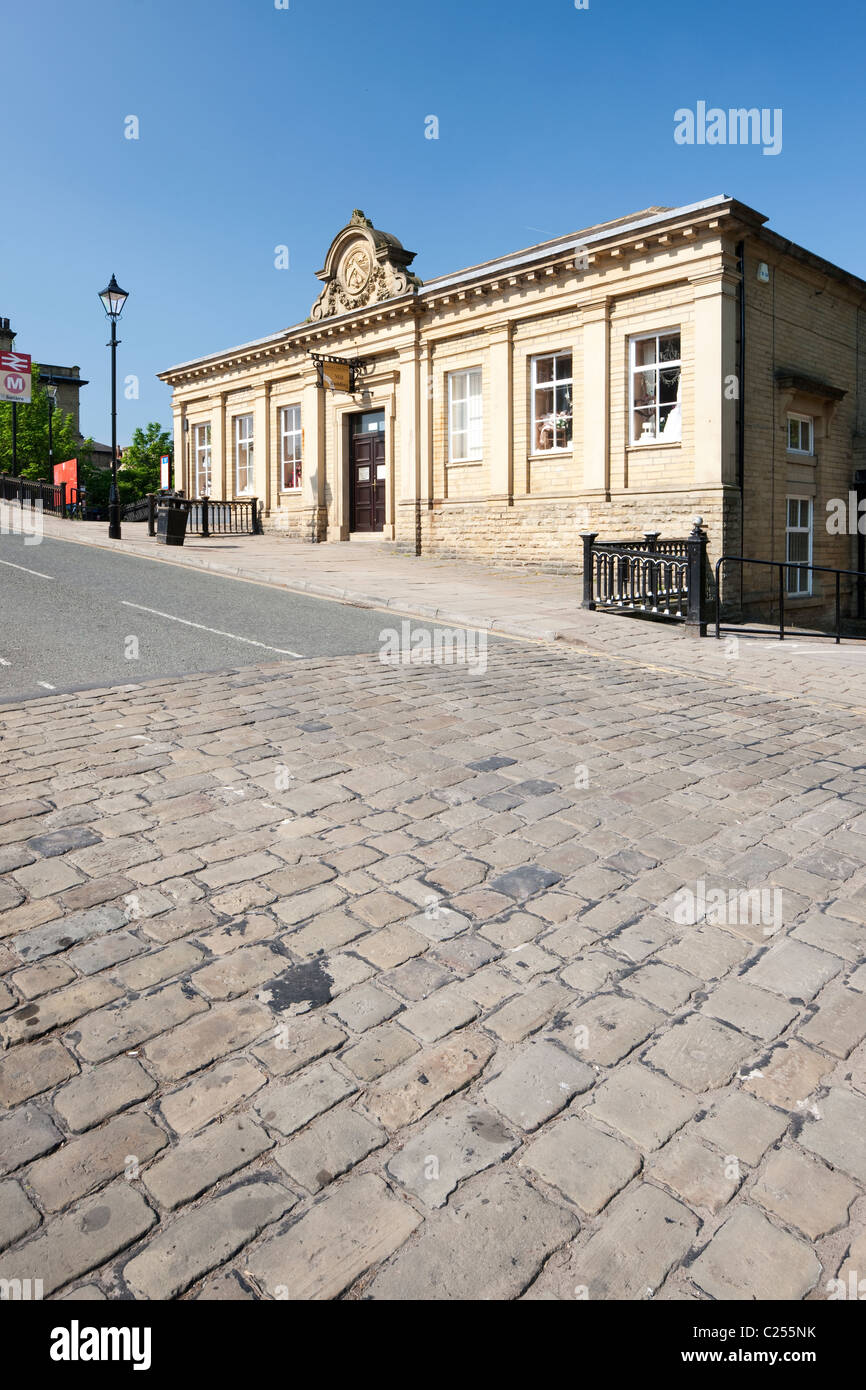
[0,642,866,1301]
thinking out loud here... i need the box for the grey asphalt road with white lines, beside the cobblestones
[0,535,408,702]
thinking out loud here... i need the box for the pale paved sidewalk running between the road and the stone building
[10,507,866,713]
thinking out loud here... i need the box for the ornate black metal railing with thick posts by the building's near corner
[582,517,714,637]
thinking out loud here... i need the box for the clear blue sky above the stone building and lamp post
[0,0,866,442]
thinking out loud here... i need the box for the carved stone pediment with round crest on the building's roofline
[311,209,421,322]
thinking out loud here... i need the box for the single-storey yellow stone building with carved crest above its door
[161,196,866,619]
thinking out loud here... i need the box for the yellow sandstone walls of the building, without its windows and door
[162,213,866,619]
